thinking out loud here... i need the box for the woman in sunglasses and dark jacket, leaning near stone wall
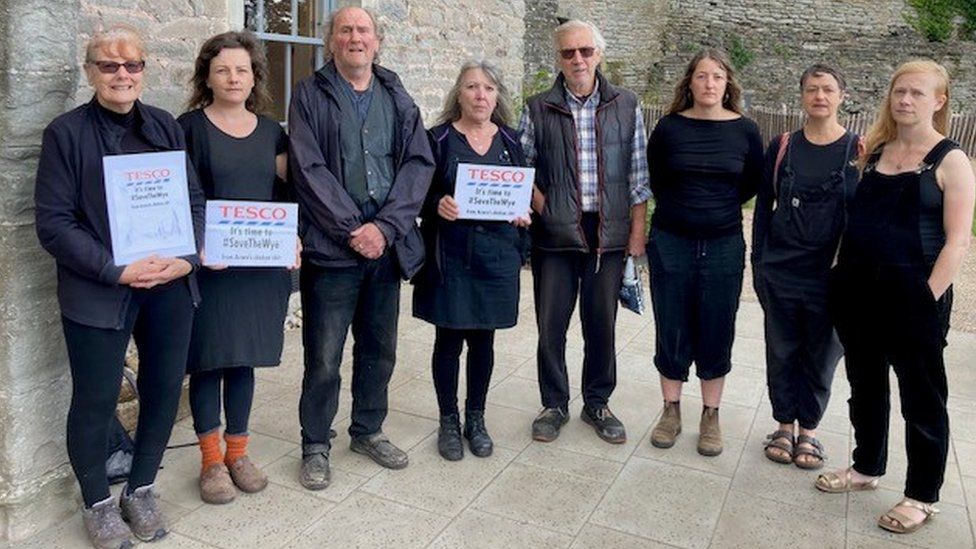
[34,26,204,548]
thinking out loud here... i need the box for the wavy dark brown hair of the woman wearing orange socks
[187,31,271,113]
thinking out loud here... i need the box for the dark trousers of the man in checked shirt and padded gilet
[532,214,624,410]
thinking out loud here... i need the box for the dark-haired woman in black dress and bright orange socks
[179,32,299,503]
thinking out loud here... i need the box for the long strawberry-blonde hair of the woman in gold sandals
[857,59,952,169]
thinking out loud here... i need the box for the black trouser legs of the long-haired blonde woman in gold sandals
[831,269,952,503]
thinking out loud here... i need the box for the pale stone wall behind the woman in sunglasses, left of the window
[0,0,227,540]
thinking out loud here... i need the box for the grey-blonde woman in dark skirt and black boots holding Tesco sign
[413,62,529,461]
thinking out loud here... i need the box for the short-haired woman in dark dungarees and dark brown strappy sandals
[752,64,858,469]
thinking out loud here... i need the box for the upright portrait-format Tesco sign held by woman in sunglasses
[102,151,197,266]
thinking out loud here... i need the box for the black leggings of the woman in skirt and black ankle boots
[431,326,495,415]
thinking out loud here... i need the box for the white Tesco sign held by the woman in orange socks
[204,200,298,267]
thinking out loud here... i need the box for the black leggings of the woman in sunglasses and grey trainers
[61,280,193,507]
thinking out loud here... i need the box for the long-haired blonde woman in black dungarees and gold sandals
[816,61,976,533]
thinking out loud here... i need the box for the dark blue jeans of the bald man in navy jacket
[298,255,400,455]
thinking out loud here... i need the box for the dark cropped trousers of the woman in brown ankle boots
[647,228,745,381]
